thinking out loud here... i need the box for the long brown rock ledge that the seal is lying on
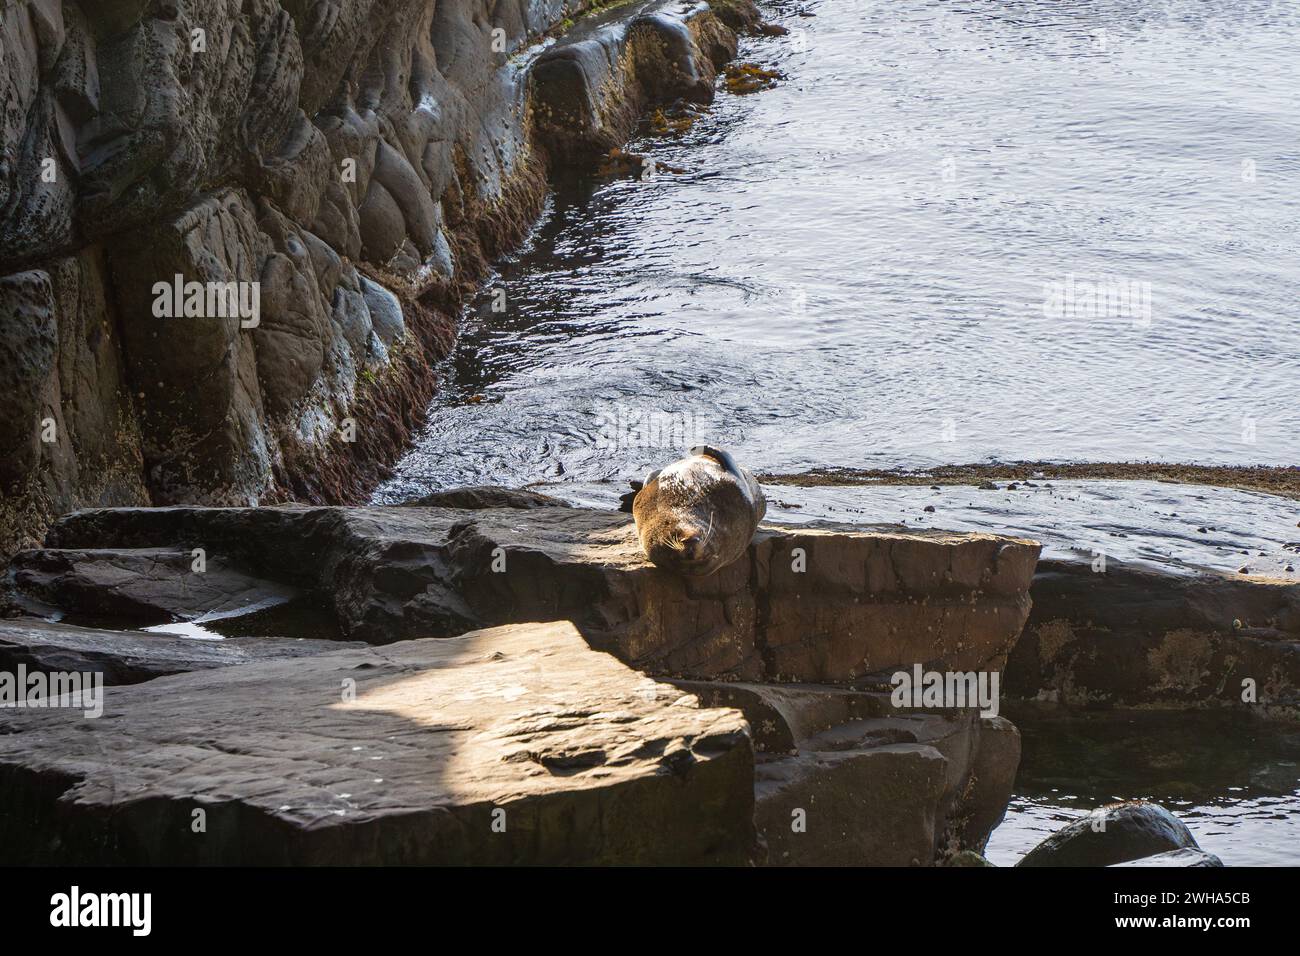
[27,507,1037,683]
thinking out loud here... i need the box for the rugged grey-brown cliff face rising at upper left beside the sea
[0,0,753,554]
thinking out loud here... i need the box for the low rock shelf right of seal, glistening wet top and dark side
[754,481,1300,723]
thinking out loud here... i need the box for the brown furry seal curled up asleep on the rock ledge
[632,445,767,578]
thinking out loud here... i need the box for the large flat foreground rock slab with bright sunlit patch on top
[0,623,754,865]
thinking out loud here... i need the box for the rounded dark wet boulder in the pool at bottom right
[1017,801,1200,866]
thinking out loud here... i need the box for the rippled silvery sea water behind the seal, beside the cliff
[380,0,1300,499]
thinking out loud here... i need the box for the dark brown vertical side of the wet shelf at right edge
[1006,561,1300,719]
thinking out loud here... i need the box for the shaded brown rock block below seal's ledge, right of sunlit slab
[675,680,1021,866]
